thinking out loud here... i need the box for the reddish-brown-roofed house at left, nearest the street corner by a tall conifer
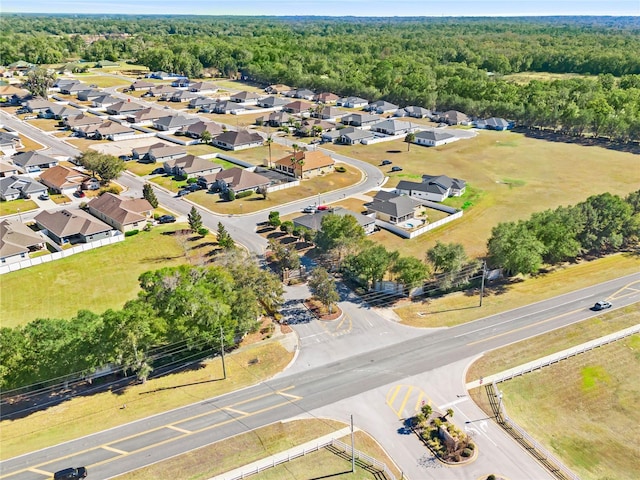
[87,192,153,232]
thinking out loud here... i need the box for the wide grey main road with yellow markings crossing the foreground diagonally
[0,273,640,480]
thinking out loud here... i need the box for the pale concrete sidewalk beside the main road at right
[466,325,640,390]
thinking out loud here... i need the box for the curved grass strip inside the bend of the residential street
[188,166,362,215]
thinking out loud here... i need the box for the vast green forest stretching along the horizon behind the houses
[0,15,640,142]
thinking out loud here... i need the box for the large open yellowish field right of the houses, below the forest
[327,131,640,257]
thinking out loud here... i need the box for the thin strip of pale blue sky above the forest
[0,0,640,17]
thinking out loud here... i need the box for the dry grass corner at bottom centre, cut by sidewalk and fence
[117,419,401,480]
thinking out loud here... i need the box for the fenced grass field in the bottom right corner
[480,335,640,480]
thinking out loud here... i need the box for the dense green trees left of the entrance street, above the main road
[0,251,282,391]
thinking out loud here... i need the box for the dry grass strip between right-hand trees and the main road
[396,253,640,328]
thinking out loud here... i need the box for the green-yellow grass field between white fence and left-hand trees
[0,224,215,327]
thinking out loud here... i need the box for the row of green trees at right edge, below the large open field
[487,190,640,274]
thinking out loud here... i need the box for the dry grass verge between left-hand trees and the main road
[0,337,293,458]
